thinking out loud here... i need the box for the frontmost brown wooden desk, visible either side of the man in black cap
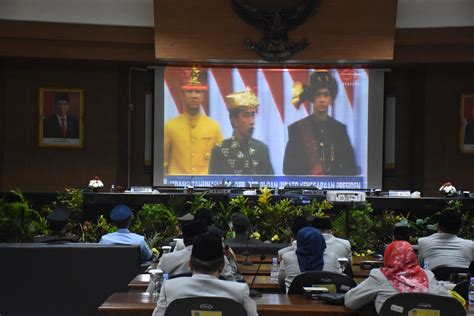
[99,292,376,316]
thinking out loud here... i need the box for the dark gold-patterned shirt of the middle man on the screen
[209,136,273,175]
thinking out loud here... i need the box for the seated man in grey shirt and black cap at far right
[418,211,474,269]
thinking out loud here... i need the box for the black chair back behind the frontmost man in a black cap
[165,296,247,316]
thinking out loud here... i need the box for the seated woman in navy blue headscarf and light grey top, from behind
[278,227,341,292]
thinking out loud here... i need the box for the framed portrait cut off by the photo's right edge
[459,93,474,153]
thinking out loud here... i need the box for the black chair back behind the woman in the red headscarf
[379,293,466,316]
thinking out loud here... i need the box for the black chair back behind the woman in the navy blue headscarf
[288,271,357,294]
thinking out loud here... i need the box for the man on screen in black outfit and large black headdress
[283,71,359,175]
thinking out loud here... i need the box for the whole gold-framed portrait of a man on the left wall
[38,88,84,148]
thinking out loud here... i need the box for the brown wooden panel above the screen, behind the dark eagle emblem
[155,0,397,63]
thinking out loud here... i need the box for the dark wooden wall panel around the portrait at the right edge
[420,64,474,195]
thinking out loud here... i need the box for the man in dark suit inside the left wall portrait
[43,92,79,138]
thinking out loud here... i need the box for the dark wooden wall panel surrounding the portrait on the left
[3,60,119,192]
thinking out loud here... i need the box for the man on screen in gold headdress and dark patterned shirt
[209,89,273,175]
